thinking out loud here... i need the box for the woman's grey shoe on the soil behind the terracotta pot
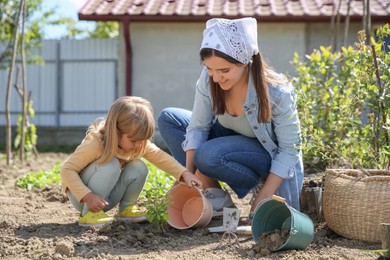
[204,188,236,217]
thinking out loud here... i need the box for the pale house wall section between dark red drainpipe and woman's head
[129,23,202,115]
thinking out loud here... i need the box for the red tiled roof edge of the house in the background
[79,0,390,23]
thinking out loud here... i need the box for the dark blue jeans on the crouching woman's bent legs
[157,108,272,198]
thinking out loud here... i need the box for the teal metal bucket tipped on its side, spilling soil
[252,195,314,251]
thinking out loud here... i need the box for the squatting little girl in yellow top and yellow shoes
[61,96,202,226]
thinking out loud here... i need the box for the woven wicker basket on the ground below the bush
[323,169,390,242]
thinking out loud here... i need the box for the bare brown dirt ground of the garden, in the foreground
[0,153,381,260]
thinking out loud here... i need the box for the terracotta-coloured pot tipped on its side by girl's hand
[168,183,213,229]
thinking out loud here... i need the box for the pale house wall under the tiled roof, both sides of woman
[128,23,306,119]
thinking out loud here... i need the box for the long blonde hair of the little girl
[87,96,155,164]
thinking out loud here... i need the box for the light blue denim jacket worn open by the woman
[182,68,303,179]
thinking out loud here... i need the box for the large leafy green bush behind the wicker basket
[292,24,390,170]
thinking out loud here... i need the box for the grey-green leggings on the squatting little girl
[68,158,148,216]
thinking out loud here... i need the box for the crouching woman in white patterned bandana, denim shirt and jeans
[158,18,303,217]
